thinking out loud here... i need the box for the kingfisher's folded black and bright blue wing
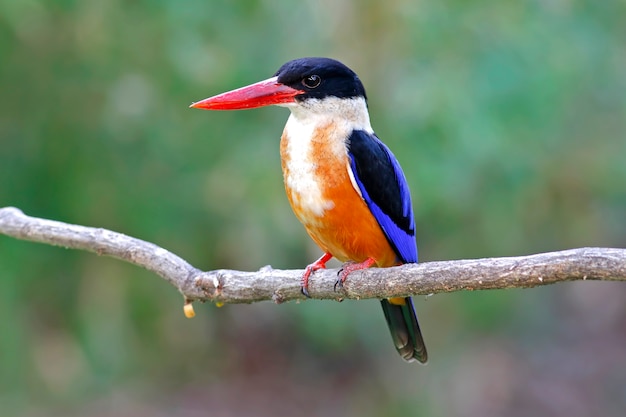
[348,130,417,263]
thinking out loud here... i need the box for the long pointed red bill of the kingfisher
[189,77,304,110]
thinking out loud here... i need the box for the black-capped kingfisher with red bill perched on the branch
[190,57,428,363]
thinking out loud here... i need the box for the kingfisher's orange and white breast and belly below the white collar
[281,120,398,267]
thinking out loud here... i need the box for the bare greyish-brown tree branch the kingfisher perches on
[0,207,626,303]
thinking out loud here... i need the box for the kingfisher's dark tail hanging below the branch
[380,297,428,363]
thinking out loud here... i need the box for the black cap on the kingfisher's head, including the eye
[274,58,367,101]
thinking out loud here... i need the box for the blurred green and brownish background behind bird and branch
[0,0,626,417]
